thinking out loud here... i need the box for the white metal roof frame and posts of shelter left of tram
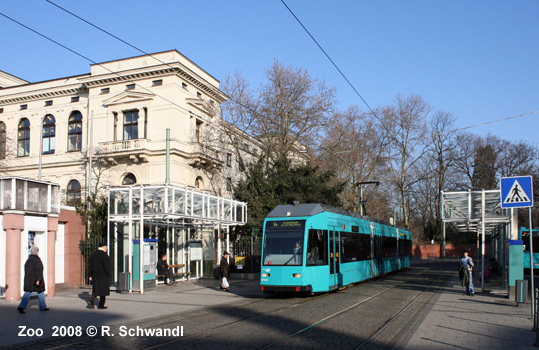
[107,185,247,293]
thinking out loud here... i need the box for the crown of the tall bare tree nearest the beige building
[223,60,335,163]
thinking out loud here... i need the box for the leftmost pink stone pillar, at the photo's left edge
[4,213,24,301]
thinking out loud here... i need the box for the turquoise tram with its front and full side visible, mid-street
[260,204,412,293]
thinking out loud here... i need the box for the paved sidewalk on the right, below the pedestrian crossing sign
[404,274,536,350]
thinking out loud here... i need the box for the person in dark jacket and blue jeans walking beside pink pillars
[17,245,49,314]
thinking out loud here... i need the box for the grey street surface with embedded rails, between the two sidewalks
[4,263,456,350]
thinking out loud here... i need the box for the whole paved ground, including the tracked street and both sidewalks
[0,263,535,350]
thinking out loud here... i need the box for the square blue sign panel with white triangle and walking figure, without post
[500,176,533,208]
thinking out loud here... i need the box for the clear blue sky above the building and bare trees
[0,0,539,145]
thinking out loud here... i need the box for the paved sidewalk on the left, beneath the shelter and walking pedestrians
[0,279,263,349]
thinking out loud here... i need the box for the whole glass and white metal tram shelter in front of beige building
[108,185,247,293]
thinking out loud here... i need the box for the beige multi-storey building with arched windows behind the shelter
[0,50,260,284]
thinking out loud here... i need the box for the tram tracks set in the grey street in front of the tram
[8,266,453,350]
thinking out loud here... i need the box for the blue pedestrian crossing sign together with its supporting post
[500,176,537,318]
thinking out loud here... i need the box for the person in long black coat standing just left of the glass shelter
[88,242,110,309]
